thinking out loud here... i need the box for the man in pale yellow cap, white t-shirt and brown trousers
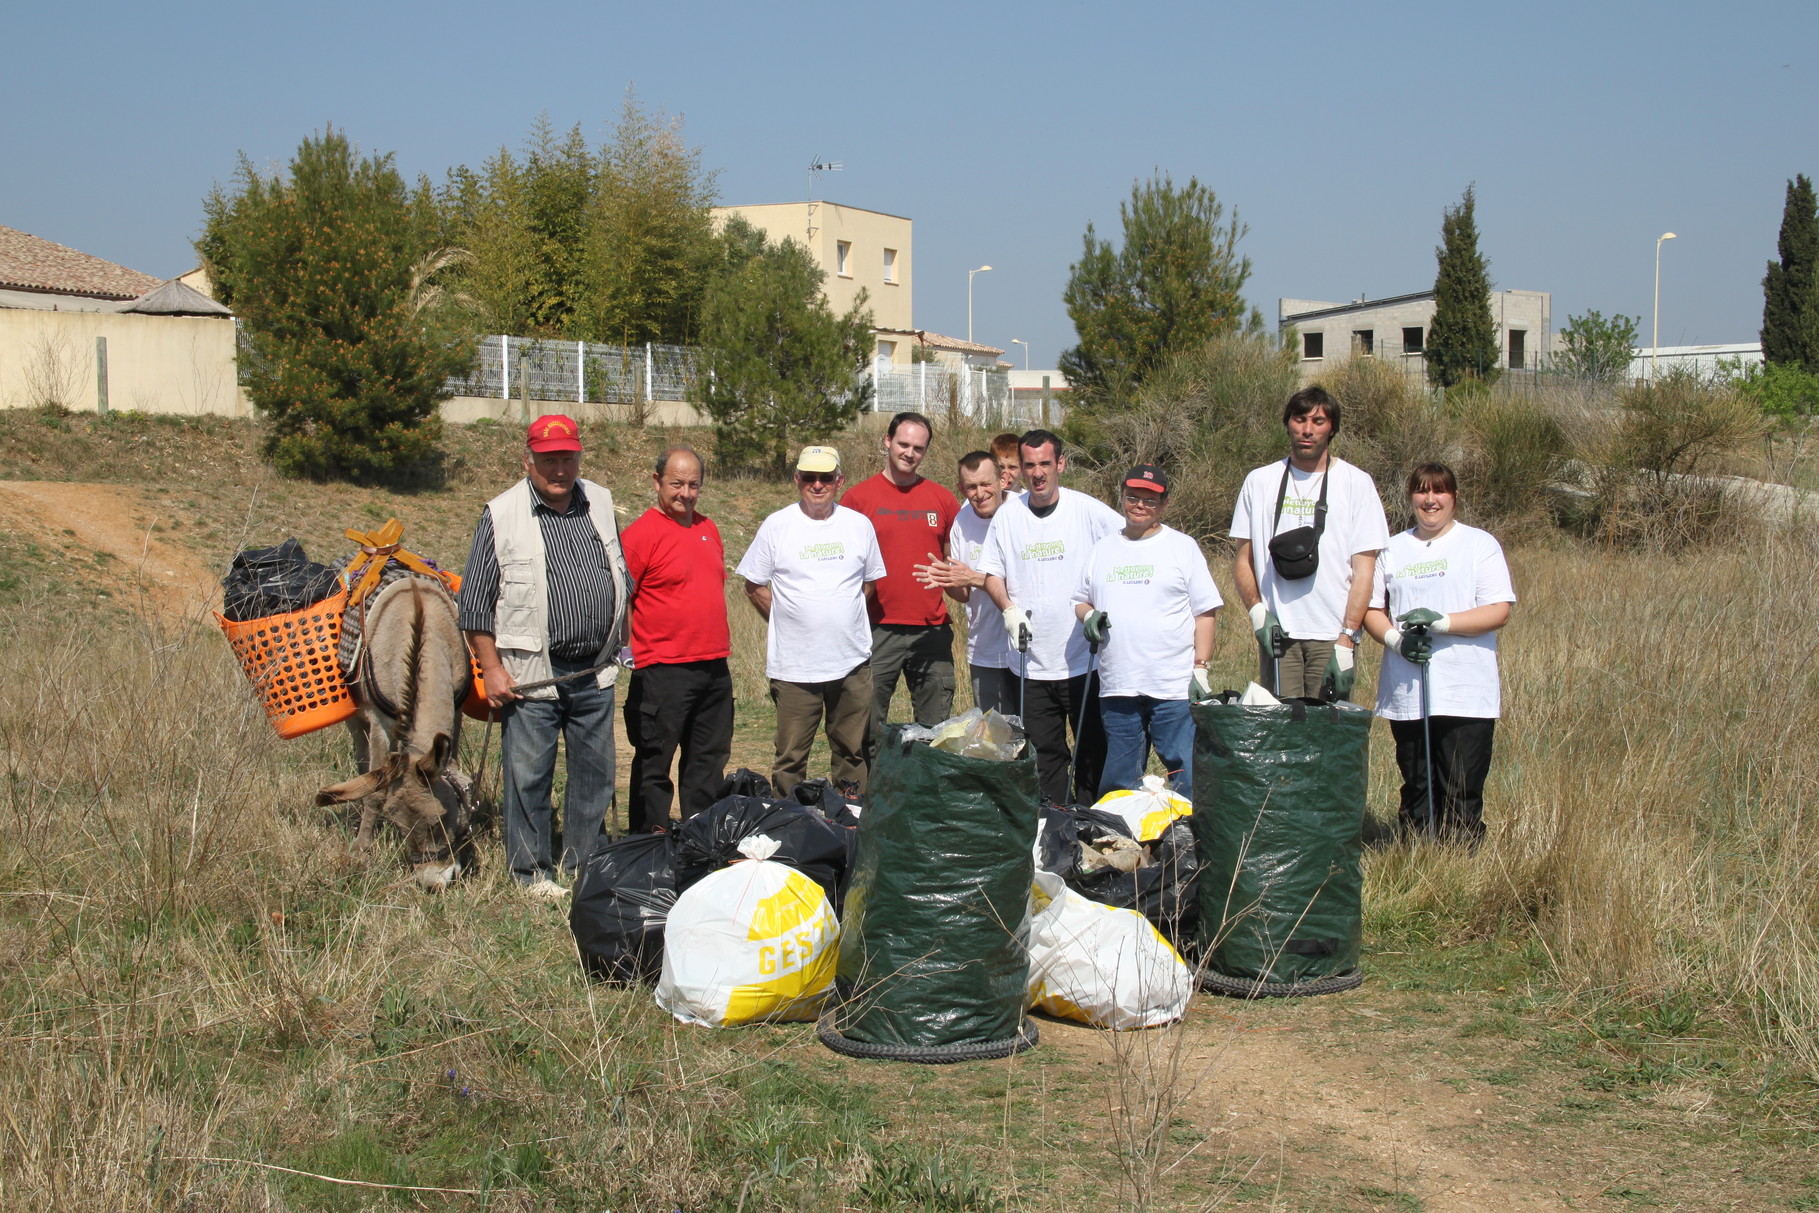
[739,446,884,797]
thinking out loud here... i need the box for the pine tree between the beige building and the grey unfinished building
[1060,175,1261,413]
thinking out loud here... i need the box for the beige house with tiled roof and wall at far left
[0,227,251,416]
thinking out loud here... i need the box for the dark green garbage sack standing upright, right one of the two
[1188,691,1372,993]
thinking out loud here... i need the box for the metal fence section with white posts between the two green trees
[446,335,700,404]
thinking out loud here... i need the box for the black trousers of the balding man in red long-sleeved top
[626,657,733,835]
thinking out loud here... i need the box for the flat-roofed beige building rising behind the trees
[713,202,915,366]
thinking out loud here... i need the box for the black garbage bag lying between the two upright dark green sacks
[1037,806,1201,947]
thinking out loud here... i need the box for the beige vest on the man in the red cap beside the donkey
[486,478,631,698]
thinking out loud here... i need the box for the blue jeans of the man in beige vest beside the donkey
[500,658,613,884]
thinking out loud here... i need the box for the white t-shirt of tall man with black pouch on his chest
[1231,458,1390,640]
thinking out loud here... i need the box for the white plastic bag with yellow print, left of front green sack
[657,835,840,1028]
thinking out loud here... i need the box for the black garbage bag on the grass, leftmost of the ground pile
[569,835,677,984]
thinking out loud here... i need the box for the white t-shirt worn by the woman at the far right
[1370,522,1515,720]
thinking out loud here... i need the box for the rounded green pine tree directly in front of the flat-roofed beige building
[702,216,873,469]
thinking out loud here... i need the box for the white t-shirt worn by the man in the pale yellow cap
[739,504,884,682]
